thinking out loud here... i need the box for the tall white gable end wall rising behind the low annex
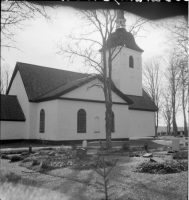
[7,71,30,139]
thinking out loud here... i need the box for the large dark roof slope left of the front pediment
[7,62,89,101]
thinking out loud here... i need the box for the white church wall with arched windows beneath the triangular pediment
[55,100,129,140]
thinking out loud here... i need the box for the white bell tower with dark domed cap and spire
[107,10,143,96]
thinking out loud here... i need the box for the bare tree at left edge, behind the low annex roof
[0,65,12,94]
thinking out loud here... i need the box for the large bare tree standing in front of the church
[57,10,148,148]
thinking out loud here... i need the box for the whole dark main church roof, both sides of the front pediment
[7,62,157,111]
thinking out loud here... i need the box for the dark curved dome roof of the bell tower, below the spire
[100,28,143,52]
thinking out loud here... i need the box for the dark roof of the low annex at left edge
[1,95,26,121]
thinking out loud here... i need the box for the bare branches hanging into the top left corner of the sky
[1,0,53,58]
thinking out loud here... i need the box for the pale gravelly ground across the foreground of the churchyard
[0,138,188,200]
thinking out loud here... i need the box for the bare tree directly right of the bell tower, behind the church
[143,57,162,137]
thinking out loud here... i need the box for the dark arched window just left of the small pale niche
[77,109,86,133]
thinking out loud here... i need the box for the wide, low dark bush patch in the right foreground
[135,161,188,174]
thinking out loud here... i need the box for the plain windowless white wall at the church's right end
[129,110,155,137]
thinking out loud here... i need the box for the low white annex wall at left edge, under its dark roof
[0,121,26,140]
